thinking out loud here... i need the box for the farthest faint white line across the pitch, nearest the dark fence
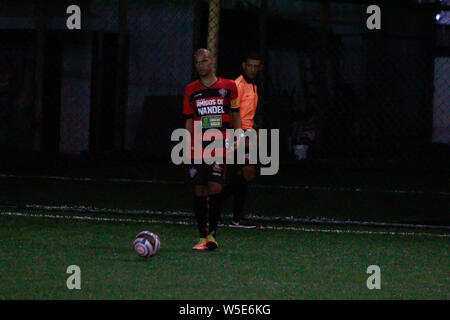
[0,174,450,196]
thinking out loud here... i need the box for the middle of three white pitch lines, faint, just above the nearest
[19,205,450,230]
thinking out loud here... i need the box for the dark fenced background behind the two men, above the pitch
[0,0,450,177]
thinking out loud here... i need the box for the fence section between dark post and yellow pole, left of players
[124,1,194,160]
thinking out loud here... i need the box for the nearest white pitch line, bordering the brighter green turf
[0,212,450,238]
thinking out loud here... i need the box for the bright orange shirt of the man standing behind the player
[235,75,258,130]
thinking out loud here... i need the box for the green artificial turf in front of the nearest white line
[0,212,450,299]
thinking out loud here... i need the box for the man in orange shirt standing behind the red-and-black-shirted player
[225,53,262,229]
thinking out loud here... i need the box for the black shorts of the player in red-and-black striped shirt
[187,163,227,186]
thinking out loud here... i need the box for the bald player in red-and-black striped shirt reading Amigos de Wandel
[183,49,241,251]
